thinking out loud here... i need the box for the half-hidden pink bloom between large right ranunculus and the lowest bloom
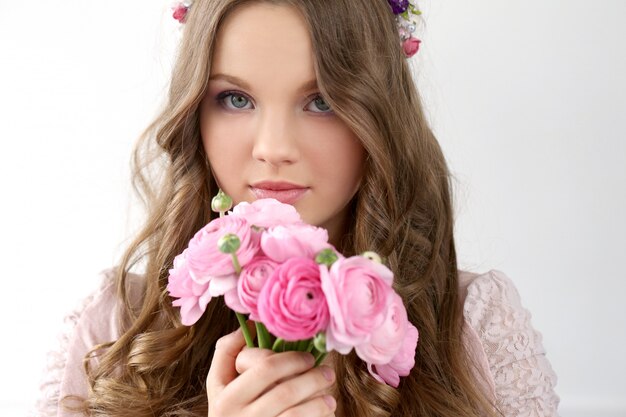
[355,292,409,365]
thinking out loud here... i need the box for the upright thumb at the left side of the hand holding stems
[206,322,254,392]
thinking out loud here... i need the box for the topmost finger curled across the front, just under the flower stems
[222,351,315,404]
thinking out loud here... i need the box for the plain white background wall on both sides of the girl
[0,0,626,417]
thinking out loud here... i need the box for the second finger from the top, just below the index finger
[246,366,335,416]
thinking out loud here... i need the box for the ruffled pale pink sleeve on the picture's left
[32,268,118,417]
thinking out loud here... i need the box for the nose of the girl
[252,107,300,166]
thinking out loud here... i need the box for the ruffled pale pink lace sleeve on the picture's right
[464,270,559,417]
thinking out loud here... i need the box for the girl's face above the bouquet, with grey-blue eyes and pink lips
[200,3,365,244]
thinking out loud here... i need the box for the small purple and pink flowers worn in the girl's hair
[172,0,422,58]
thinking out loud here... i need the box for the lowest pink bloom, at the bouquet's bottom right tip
[367,323,419,388]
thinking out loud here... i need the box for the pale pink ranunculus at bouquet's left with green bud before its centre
[187,216,260,288]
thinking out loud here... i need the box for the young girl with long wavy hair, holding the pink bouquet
[36,0,558,417]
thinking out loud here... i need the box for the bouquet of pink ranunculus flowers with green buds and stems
[167,191,418,387]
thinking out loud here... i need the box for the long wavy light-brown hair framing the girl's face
[72,0,495,417]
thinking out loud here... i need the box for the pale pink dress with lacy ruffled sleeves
[34,269,559,417]
